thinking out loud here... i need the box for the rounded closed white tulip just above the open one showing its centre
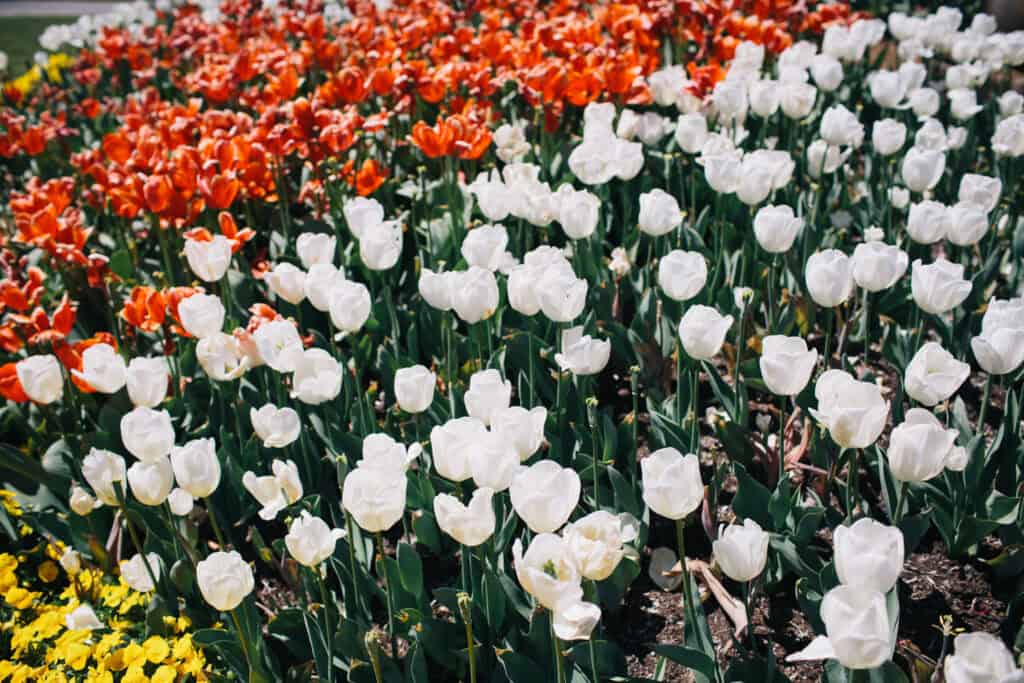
[509,460,583,533]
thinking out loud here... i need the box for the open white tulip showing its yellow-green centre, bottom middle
[512,533,583,609]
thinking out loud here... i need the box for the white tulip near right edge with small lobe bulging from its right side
[886,408,968,482]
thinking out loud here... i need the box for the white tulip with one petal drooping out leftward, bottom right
[785,585,896,669]
